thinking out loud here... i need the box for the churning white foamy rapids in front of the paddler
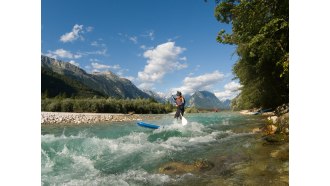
[41,122,250,185]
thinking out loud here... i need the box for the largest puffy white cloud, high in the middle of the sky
[138,42,187,88]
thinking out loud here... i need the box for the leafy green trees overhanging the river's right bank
[215,0,289,109]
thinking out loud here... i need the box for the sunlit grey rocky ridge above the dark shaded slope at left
[41,56,151,99]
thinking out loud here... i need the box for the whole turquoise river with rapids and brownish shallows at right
[41,112,289,186]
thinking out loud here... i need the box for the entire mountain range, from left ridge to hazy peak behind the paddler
[41,55,230,109]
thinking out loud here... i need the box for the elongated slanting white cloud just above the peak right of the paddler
[171,70,224,94]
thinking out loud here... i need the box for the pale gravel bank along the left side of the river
[41,112,157,125]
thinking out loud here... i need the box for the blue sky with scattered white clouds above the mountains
[41,0,240,100]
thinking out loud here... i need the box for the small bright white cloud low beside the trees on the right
[214,81,242,101]
